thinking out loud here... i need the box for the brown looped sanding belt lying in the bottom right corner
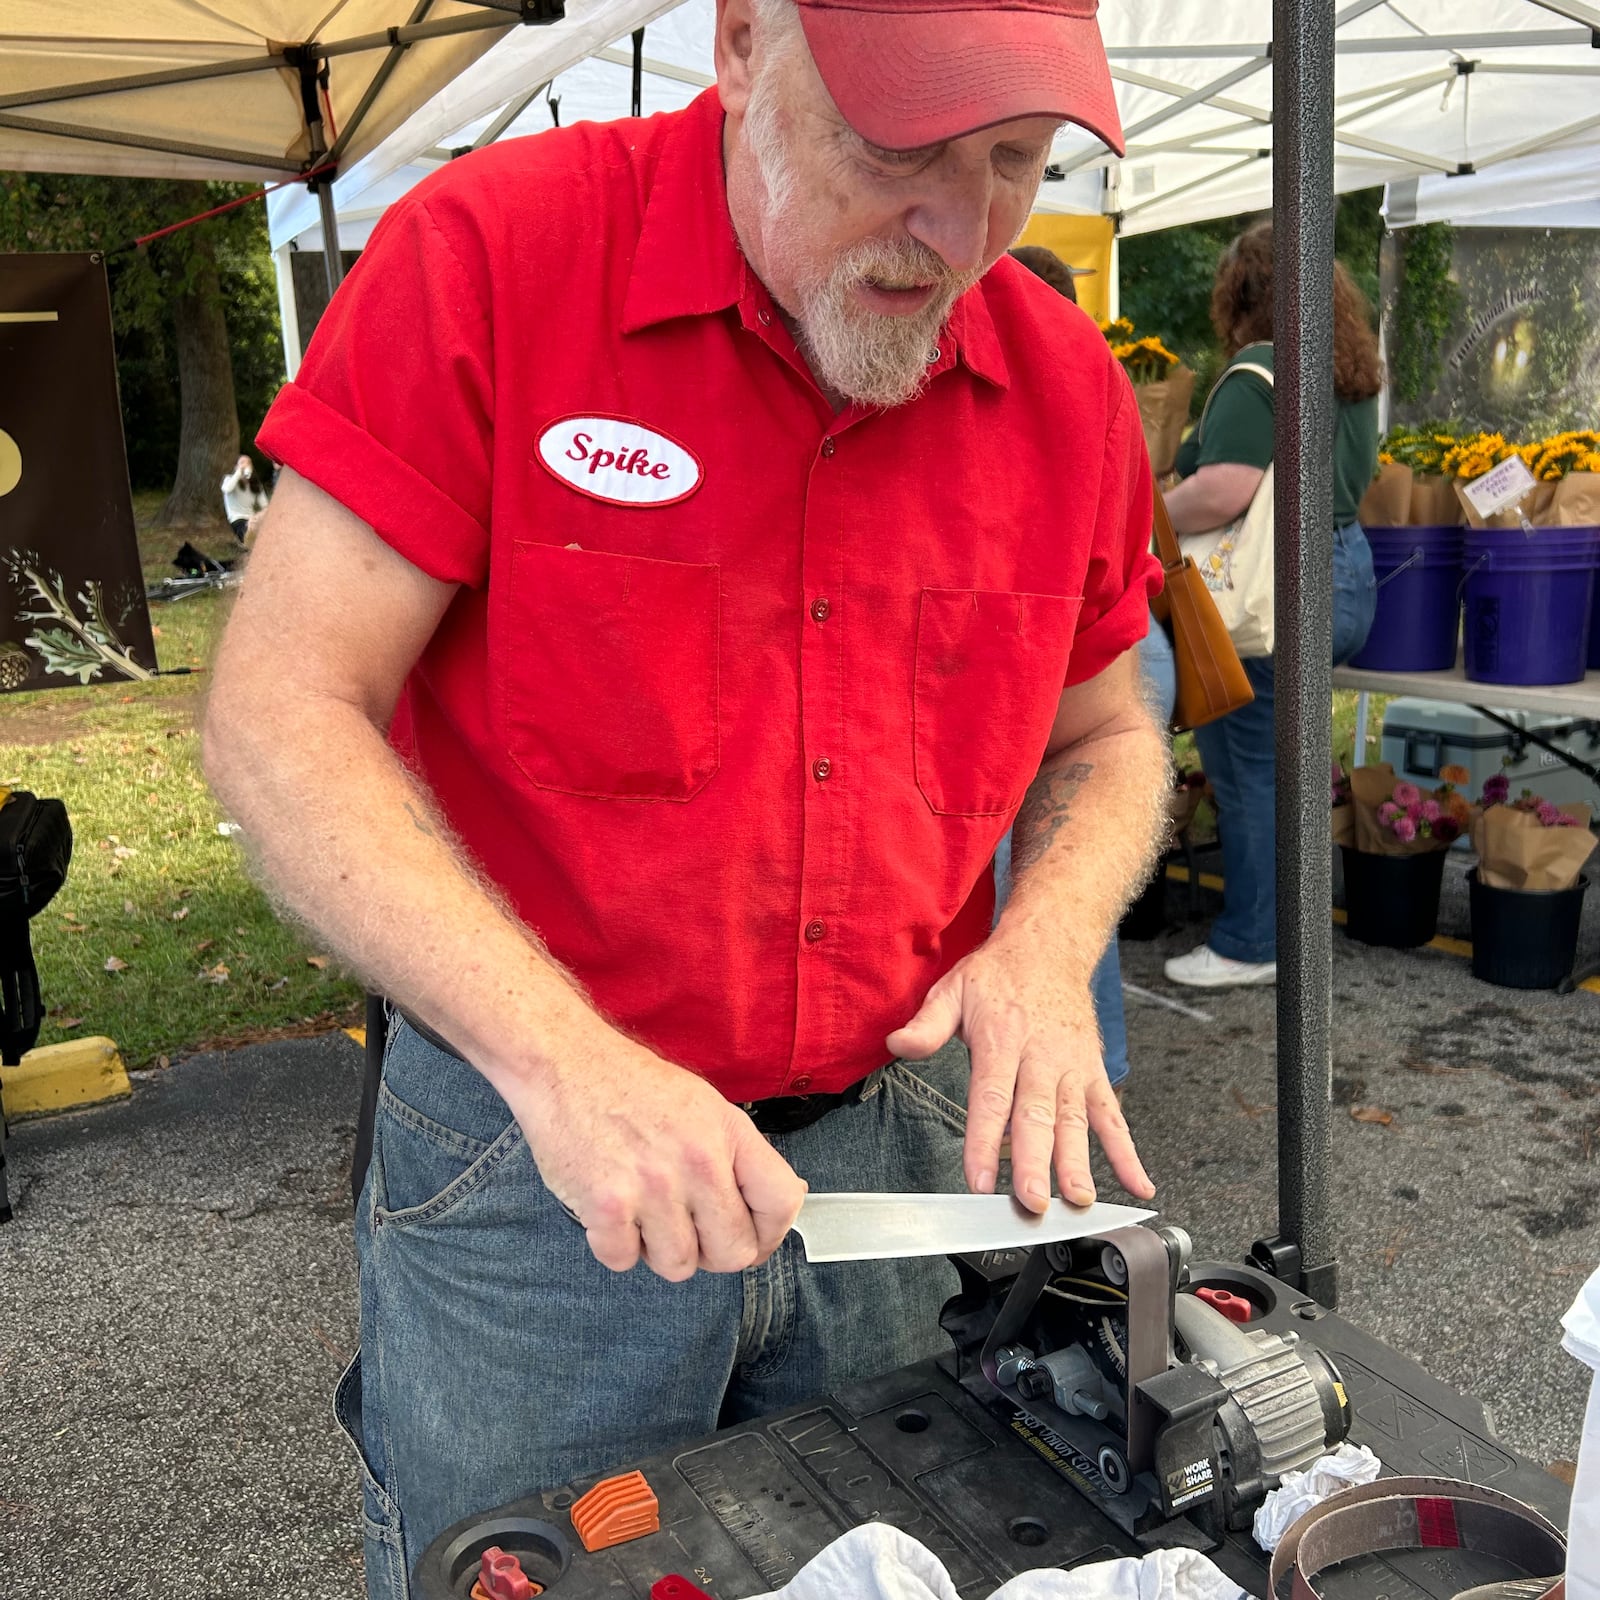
[1267,1478,1566,1600]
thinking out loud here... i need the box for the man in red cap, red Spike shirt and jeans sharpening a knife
[206,0,1165,1595]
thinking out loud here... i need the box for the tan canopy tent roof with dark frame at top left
[0,0,670,291]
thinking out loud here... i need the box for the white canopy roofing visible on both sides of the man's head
[272,0,1600,248]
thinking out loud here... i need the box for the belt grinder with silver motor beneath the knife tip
[939,1227,1350,1536]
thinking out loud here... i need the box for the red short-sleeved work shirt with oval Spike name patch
[259,93,1160,1101]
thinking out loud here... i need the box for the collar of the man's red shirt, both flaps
[622,88,1011,389]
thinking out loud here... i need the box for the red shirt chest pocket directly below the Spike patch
[494,542,722,800]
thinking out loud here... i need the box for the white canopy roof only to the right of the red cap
[1043,0,1600,234]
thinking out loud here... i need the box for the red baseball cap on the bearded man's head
[797,0,1123,155]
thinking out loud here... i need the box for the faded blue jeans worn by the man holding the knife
[347,1022,968,1600]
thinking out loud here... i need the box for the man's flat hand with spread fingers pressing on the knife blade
[888,939,1155,1211]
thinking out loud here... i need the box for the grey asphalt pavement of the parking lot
[0,861,1600,1600]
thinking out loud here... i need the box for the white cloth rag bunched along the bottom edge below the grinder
[742,1522,1250,1600]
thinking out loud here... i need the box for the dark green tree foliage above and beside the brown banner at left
[0,173,283,488]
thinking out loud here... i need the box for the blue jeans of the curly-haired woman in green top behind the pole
[1195,522,1378,962]
